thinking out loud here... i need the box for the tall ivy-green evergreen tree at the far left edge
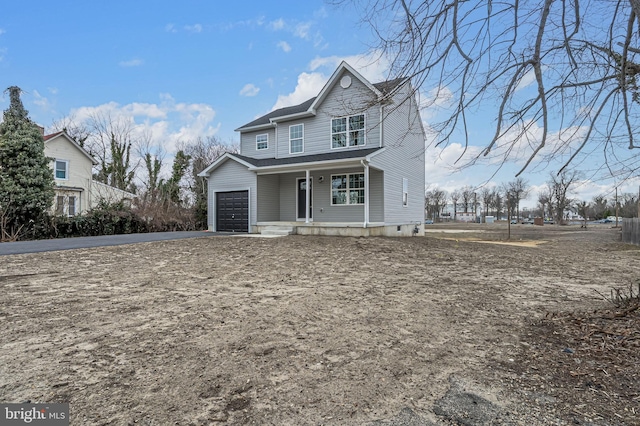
[0,86,54,227]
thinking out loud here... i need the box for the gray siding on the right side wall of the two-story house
[371,85,425,224]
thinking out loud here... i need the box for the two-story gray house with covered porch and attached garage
[199,62,425,236]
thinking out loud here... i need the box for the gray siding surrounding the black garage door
[208,160,257,232]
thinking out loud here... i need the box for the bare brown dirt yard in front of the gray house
[0,224,640,425]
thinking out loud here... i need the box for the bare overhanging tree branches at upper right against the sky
[333,0,640,178]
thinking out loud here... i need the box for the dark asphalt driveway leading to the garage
[0,231,229,256]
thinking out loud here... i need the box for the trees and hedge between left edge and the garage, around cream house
[0,86,237,241]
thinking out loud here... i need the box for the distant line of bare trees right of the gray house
[425,169,639,223]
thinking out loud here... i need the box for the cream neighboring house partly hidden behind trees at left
[44,131,135,216]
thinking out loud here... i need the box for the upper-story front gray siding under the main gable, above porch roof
[274,70,380,158]
